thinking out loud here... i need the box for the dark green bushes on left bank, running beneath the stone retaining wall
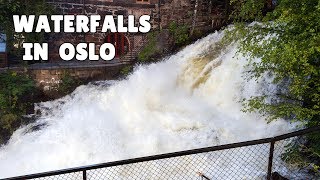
[0,71,85,145]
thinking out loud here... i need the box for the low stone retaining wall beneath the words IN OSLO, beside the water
[0,63,128,97]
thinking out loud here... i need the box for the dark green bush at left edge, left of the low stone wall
[0,72,35,144]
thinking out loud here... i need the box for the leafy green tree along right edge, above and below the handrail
[228,0,320,174]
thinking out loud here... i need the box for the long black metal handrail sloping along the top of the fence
[3,126,320,180]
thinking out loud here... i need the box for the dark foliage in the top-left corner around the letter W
[0,0,54,55]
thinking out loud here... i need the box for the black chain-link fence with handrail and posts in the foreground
[3,127,320,180]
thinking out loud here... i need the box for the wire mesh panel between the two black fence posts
[88,144,269,180]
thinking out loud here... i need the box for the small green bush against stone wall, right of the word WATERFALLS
[169,21,189,47]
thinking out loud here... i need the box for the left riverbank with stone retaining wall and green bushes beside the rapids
[0,60,130,145]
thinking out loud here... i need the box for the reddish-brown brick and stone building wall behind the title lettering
[47,0,227,62]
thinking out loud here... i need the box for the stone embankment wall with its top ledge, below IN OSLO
[0,60,131,99]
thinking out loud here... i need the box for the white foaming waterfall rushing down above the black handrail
[0,32,292,177]
